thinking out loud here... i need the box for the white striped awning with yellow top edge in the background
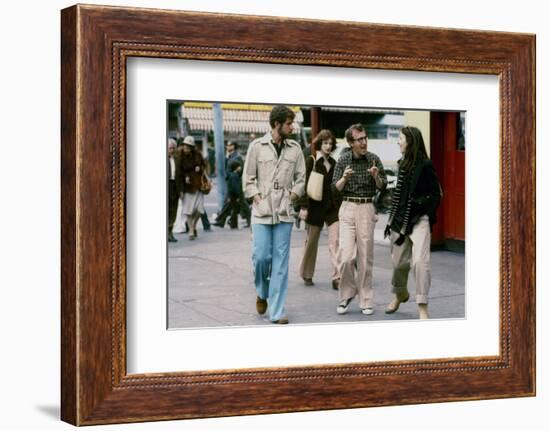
[181,102,304,133]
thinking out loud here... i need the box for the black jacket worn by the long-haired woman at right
[406,159,442,235]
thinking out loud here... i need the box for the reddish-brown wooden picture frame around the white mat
[61,5,535,425]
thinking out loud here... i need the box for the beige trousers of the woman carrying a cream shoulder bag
[300,222,340,280]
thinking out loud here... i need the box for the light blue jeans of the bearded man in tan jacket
[252,223,292,321]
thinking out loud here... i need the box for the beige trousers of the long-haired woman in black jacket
[391,216,432,304]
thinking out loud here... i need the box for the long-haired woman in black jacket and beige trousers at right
[385,127,442,319]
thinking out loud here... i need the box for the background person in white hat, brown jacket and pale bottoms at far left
[176,136,209,240]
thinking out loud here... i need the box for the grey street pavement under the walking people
[168,181,465,329]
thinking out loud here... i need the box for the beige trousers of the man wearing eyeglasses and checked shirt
[338,201,378,308]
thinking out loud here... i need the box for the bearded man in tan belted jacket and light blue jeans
[243,106,305,324]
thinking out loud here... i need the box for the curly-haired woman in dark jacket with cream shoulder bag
[299,129,341,290]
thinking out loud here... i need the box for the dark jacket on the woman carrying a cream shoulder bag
[302,156,342,227]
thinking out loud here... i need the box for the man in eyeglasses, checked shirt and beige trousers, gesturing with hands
[332,124,387,316]
